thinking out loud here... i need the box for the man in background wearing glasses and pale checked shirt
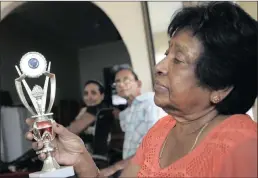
[100,66,165,177]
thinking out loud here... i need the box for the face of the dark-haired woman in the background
[83,83,104,106]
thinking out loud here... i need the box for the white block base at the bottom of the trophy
[29,166,75,178]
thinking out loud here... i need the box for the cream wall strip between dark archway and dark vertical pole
[93,1,153,92]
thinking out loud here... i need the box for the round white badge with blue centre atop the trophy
[20,52,47,78]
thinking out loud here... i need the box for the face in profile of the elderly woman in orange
[154,30,214,117]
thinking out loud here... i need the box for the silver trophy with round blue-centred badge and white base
[15,52,74,178]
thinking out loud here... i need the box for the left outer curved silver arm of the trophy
[15,75,36,115]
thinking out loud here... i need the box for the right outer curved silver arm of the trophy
[44,71,56,113]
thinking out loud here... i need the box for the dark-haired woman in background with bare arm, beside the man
[68,80,107,142]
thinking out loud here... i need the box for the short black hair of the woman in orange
[168,2,258,114]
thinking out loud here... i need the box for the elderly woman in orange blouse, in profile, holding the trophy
[27,2,258,177]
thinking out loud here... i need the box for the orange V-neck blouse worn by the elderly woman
[132,114,257,178]
